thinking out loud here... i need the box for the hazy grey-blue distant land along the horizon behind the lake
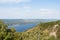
[0,19,58,24]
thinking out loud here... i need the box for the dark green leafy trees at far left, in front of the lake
[0,20,15,40]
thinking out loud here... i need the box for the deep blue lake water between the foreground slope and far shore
[8,23,37,32]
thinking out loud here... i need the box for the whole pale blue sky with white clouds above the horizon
[0,0,60,19]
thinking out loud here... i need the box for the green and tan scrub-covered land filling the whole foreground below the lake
[0,20,60,40]
